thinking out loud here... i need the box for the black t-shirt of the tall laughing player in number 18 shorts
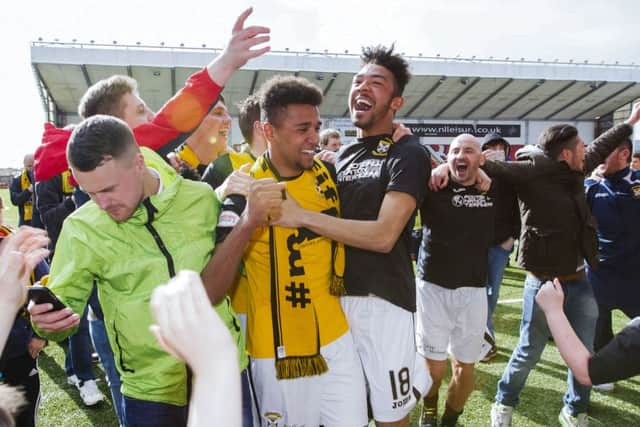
[336,135,431,312]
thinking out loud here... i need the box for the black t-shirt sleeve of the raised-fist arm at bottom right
[589,317,640,384]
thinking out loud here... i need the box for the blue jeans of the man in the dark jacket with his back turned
[496,274,598,416]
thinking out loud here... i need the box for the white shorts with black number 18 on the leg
[340,295,430,422]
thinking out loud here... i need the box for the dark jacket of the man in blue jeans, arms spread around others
[485,124,632,277]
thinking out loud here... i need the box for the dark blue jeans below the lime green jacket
[122,396,189,427]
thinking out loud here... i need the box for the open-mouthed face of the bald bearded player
[447,134,484,186]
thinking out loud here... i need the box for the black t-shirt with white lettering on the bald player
[418,179,495,289]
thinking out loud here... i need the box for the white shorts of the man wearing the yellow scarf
[251,332,368,427]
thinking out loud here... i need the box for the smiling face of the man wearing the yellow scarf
[264,104,322,177]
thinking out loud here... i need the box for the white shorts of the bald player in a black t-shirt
[416,279,488,363]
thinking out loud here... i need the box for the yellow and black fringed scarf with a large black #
[251,154,345,379]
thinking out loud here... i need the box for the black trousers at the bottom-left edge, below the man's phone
[2,352,40,427]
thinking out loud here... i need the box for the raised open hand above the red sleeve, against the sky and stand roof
[207,7,271,86]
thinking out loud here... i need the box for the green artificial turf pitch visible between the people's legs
[23,262,640,427]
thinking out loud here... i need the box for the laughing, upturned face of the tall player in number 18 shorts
[349,64,403,136]
